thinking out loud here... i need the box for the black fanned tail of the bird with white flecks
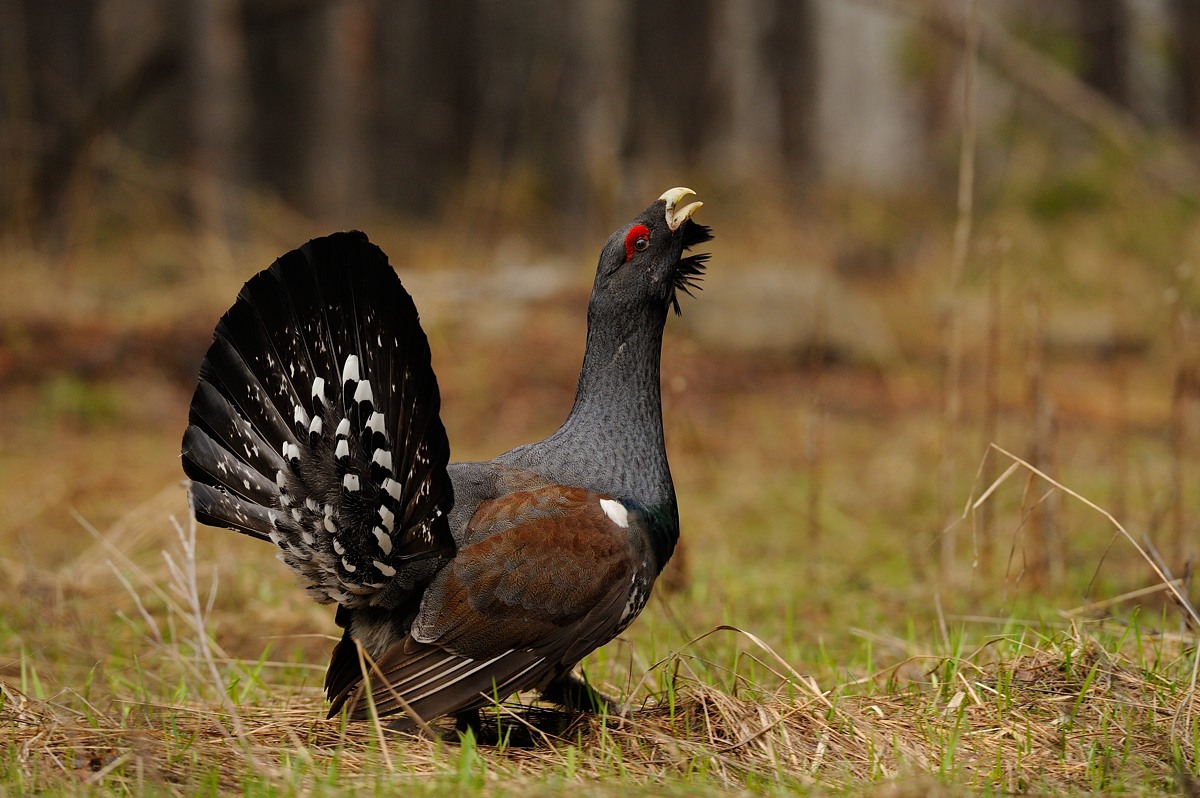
[182,233,454,607]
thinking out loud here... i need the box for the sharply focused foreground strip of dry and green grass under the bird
[9,542,1200,796]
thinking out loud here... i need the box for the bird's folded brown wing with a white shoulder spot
[331,485,643,720]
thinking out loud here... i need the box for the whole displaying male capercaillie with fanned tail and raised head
[182,188,712,726]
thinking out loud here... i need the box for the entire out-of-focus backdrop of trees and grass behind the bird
[0,0,1200,696]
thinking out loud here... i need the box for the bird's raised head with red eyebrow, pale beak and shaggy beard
[592,188,713,318]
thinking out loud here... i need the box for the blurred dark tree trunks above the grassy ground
[0,0,1200,236]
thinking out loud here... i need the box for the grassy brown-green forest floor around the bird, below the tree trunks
[0,174,1200,796]
